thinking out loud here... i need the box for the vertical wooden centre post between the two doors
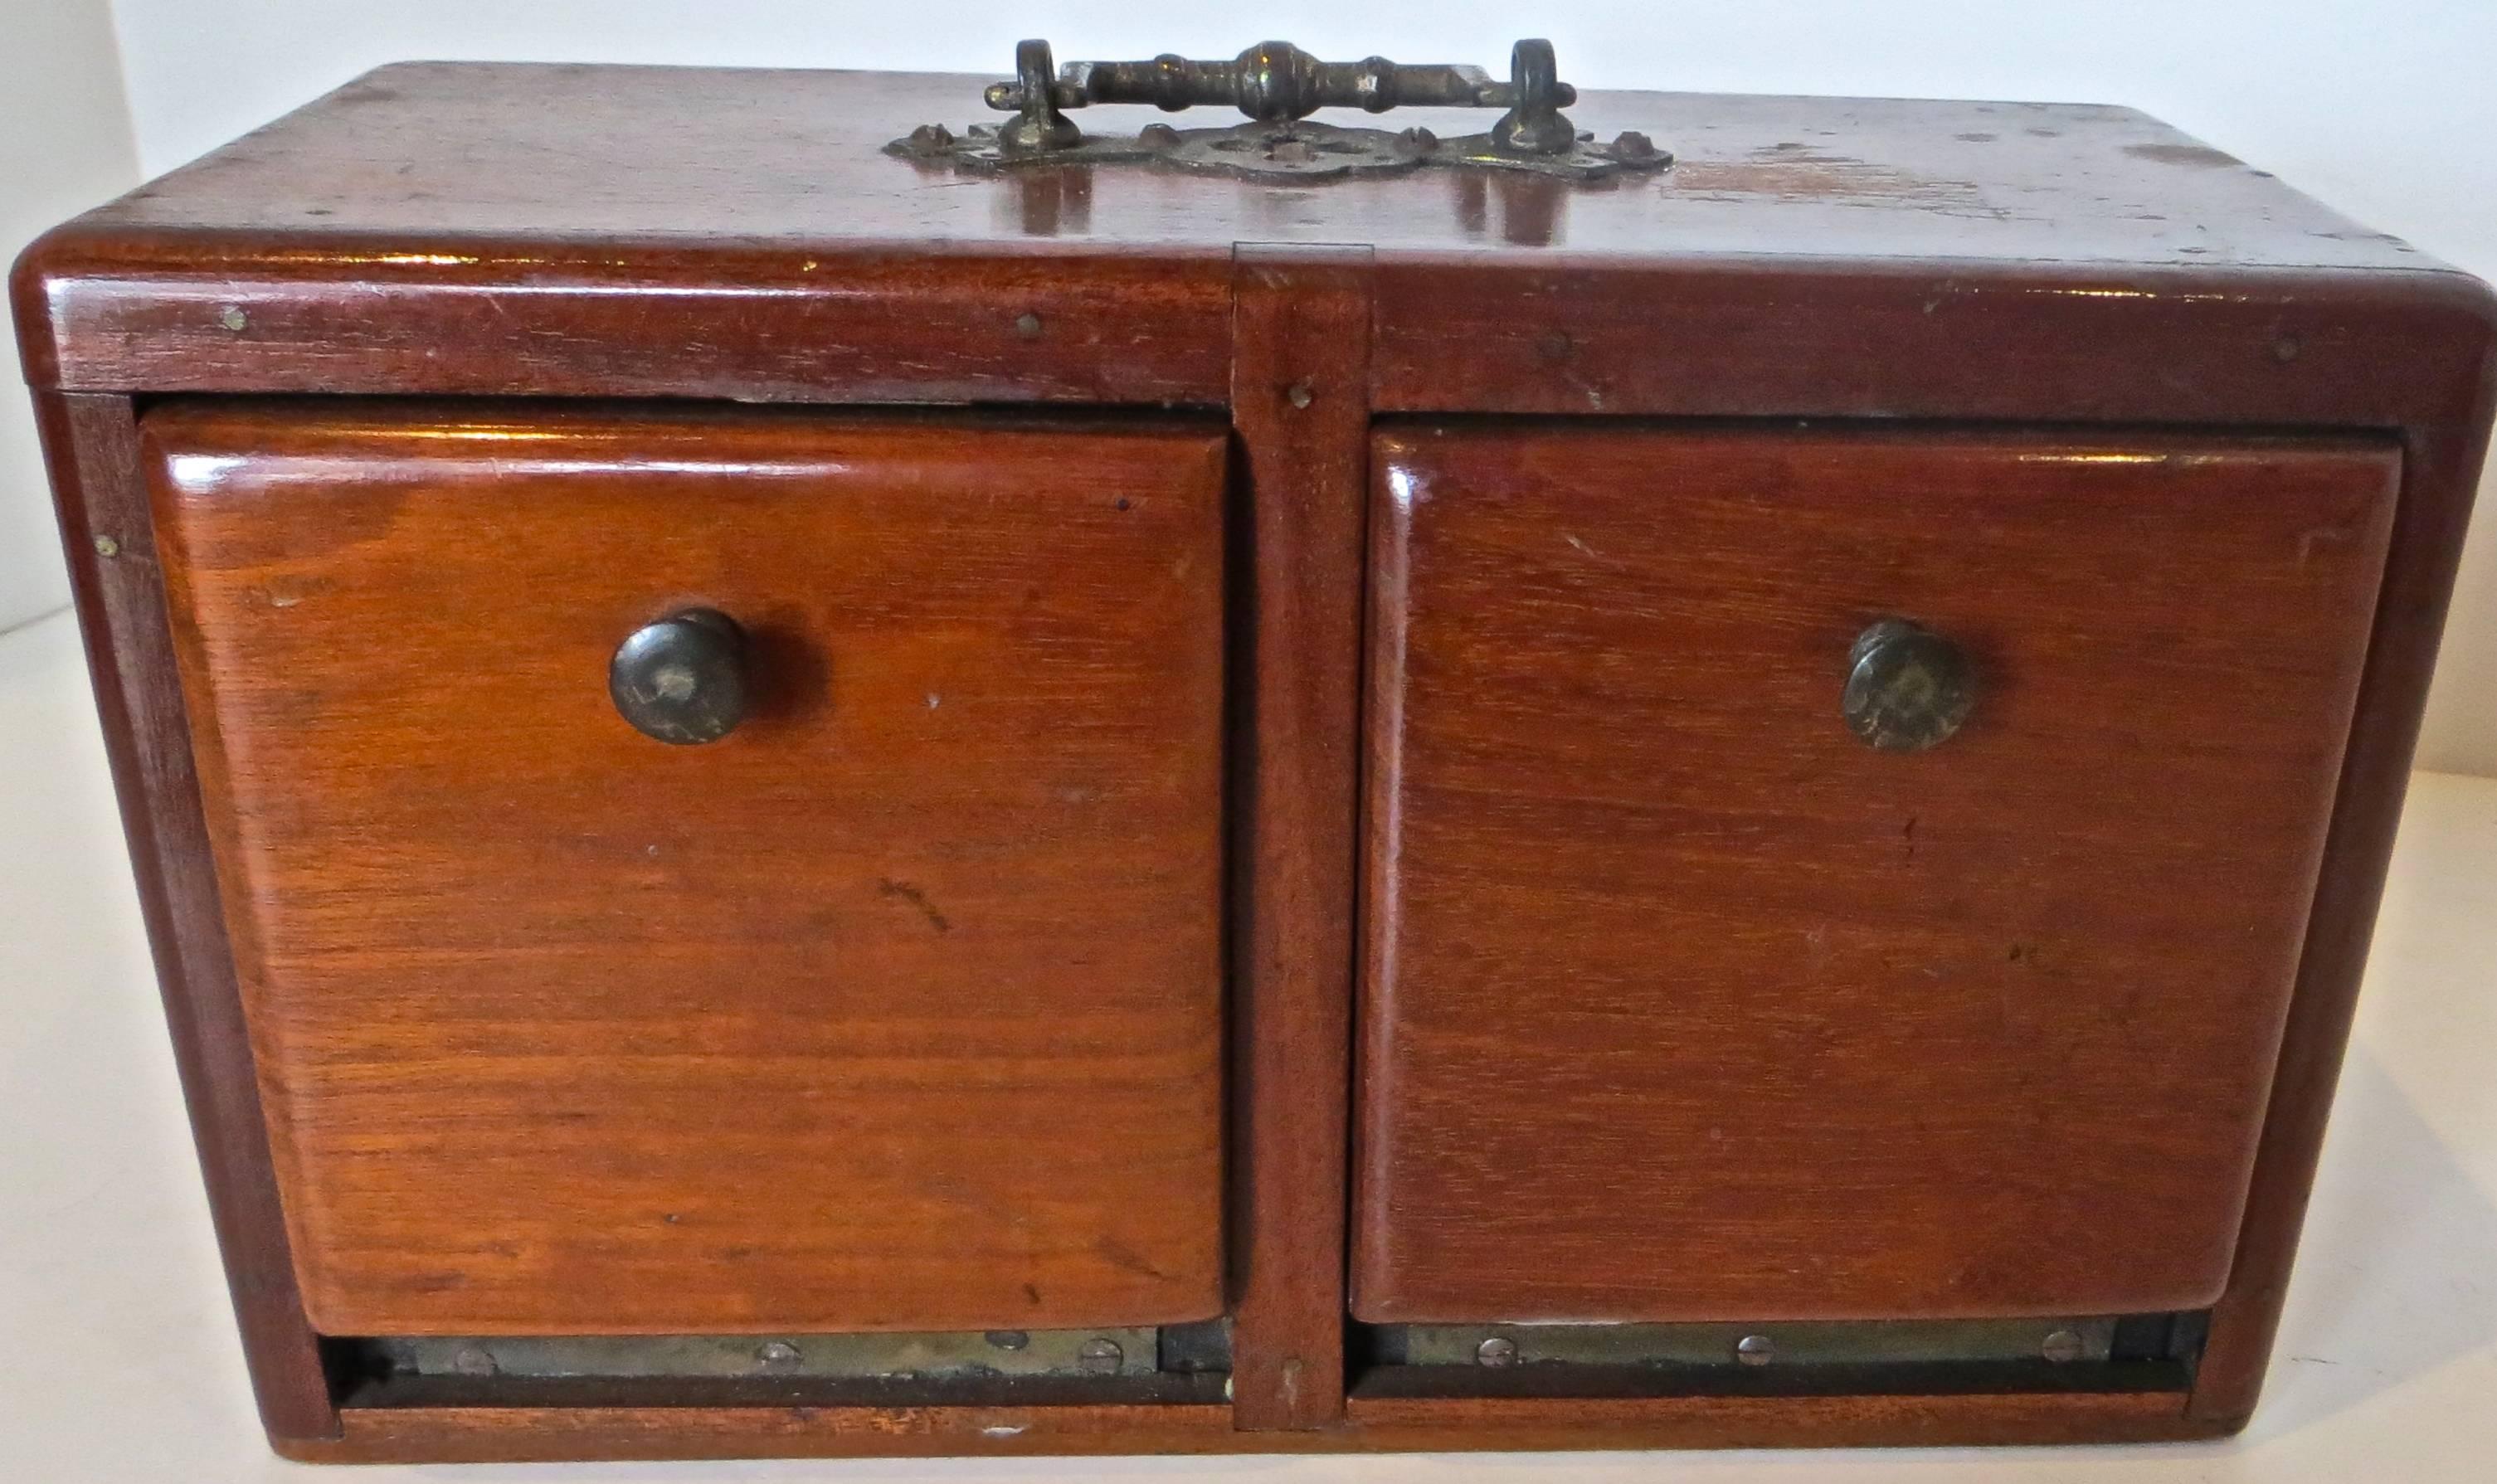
[1231,245,1370,1429]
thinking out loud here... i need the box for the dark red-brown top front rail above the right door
[1374,257,2497,427]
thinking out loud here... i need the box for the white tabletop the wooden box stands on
[0,596,2497,1484]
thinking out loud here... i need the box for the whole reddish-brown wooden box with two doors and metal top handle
[12,47,2497,1462]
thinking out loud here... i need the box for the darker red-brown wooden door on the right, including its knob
[1351,422,2400,1324]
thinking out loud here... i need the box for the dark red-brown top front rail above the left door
[17,240,1226,405]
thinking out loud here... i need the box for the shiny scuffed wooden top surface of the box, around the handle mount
[34,62,2442,270]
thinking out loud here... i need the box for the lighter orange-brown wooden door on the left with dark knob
[145,402,1224,1334]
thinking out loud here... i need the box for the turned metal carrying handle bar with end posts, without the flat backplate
[984,40,1578,155]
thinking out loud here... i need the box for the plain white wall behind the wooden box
[0,0,2497,775]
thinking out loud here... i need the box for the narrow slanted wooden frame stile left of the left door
[35,392,337,1447]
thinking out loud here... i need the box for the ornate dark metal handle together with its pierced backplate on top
[884,40,1673,180]
